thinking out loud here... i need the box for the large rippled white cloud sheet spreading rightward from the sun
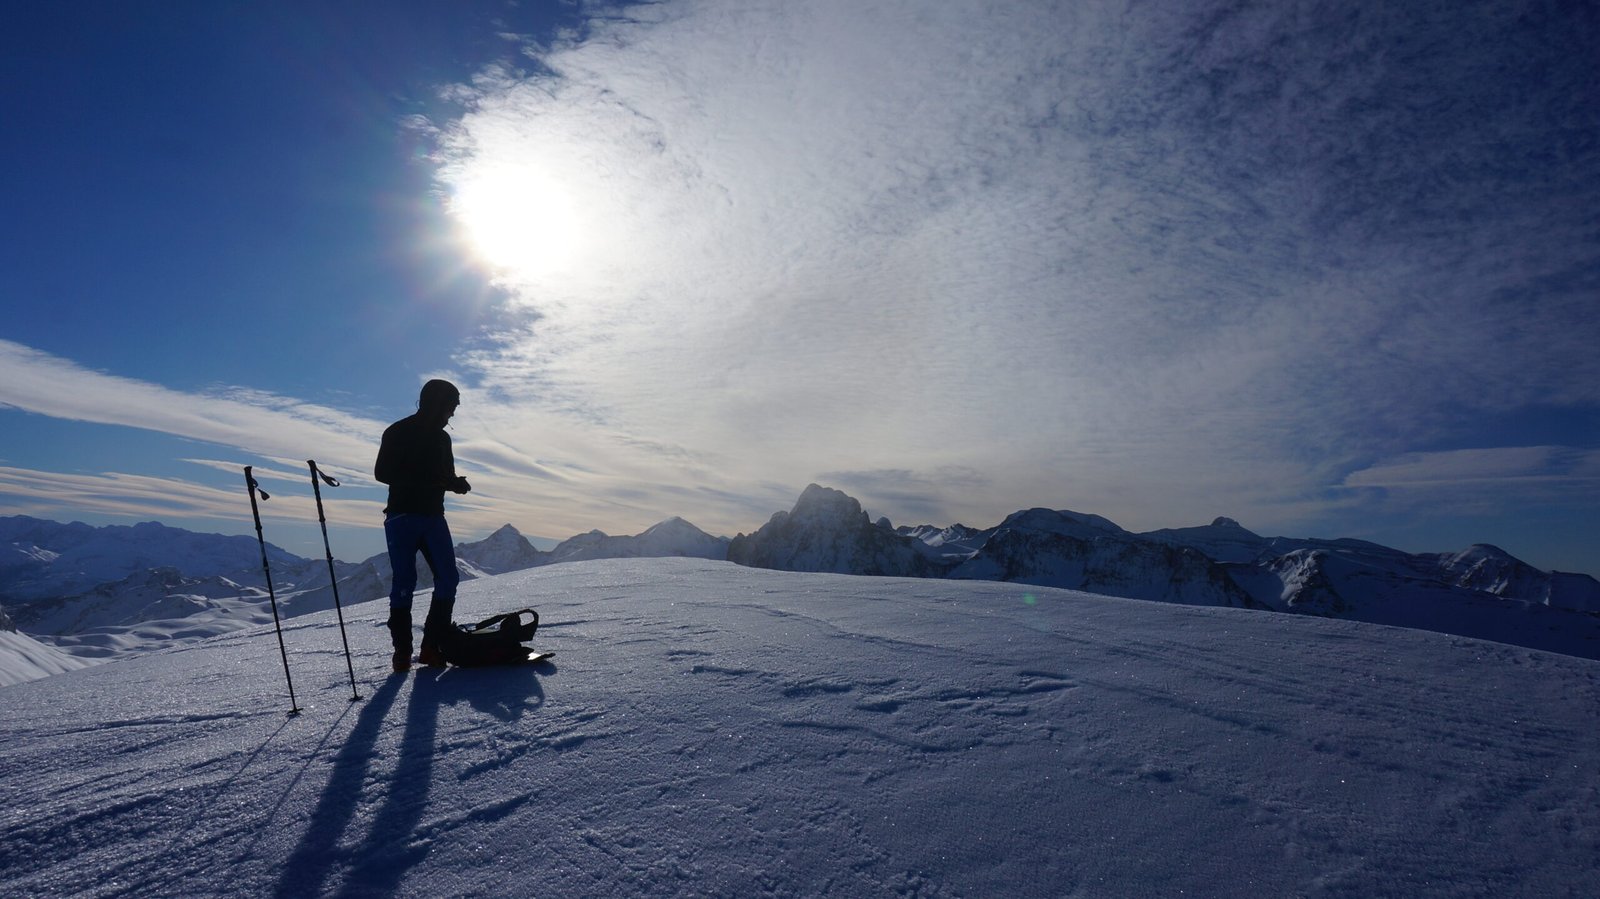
[416,2,1600,526]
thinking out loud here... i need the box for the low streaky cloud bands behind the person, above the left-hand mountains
[0,341,776,536]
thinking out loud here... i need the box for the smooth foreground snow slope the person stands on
[0,560,1600,897]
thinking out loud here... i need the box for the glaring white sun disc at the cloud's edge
[450,165,581,277]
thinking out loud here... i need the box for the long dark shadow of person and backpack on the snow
[275,665,554,899]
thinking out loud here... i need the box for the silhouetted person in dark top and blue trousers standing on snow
[374,379,472,672]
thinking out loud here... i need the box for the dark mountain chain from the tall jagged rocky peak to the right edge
[728,485,1600,657]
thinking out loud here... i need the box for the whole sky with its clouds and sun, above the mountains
[0,0,1600,574]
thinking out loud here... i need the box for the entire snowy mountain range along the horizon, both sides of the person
[0,485,1600,677]
